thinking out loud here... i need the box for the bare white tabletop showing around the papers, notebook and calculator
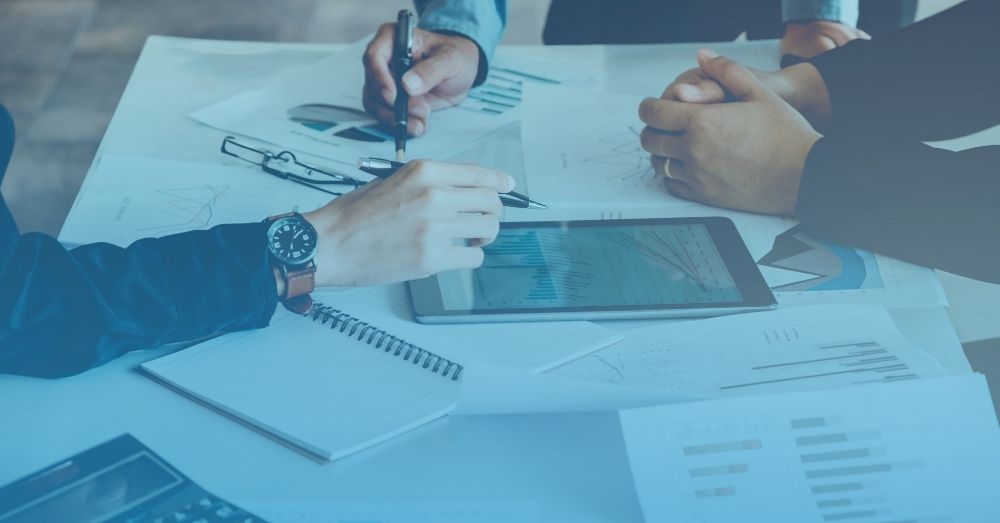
[0,38,984,522]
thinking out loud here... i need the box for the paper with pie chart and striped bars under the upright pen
[191,39,588,170]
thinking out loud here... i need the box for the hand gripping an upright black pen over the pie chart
[364,24,479,136]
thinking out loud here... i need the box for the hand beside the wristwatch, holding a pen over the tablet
[304,160,514,286]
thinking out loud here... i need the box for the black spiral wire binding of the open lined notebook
[306,303,465,380]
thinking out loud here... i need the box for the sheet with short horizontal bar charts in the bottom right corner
[620,374,1000,523]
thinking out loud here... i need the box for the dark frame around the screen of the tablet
[409,216,777,321]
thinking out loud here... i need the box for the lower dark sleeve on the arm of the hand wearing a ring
[796,136,1000,283]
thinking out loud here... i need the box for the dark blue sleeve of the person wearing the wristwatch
[0,106,277,377]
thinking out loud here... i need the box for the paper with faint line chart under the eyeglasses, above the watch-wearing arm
[59,155,333,246]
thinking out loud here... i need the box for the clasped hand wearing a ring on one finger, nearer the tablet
[639,51,820,215]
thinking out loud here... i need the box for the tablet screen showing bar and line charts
[438,223,743,310]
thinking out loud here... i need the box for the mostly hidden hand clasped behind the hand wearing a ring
[660,53,833,132]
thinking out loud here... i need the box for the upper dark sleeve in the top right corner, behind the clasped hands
[811,0,1000,141]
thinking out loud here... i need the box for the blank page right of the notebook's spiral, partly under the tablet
[313,284,622,372]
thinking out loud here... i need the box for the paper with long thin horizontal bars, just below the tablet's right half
[551,305,946,397]
